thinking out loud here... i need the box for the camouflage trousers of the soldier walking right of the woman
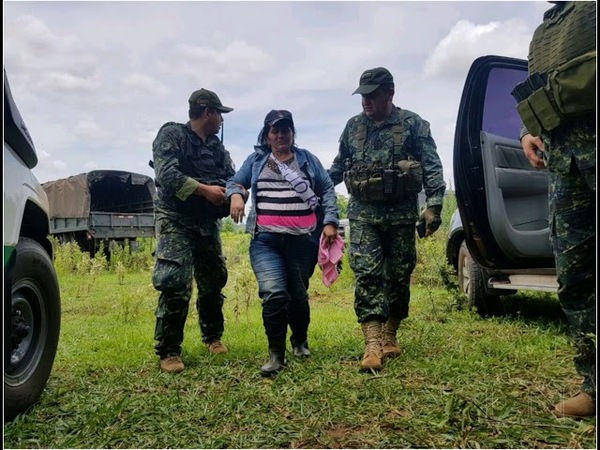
[349,220,417,323]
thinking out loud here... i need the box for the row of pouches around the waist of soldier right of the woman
[344,160,423,203]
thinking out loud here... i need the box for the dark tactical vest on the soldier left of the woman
[157,122,230,220]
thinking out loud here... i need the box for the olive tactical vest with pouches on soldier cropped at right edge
[513,1,596,136]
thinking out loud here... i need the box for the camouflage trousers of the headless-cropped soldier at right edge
[549,163,596,397]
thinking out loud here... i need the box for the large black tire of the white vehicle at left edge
[4,238,61,421]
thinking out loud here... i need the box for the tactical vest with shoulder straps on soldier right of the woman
[344,123,423,203]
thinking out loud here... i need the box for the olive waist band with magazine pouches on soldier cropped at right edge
[512,50,596,136]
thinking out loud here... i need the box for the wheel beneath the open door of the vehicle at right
[458,241,500,316]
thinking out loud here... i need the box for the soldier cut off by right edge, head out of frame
[515,2,596,418]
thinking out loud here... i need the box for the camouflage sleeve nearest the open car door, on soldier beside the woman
[416,119,446,206]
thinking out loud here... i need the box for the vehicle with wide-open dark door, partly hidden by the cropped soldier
[446,55,558,315]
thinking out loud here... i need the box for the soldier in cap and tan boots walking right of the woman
[329,67,446,371]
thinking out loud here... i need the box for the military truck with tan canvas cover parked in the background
[42,170,155,255]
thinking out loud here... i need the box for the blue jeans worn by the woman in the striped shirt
[250,233,318,343]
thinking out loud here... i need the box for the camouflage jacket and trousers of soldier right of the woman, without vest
[329,107,446,323]
